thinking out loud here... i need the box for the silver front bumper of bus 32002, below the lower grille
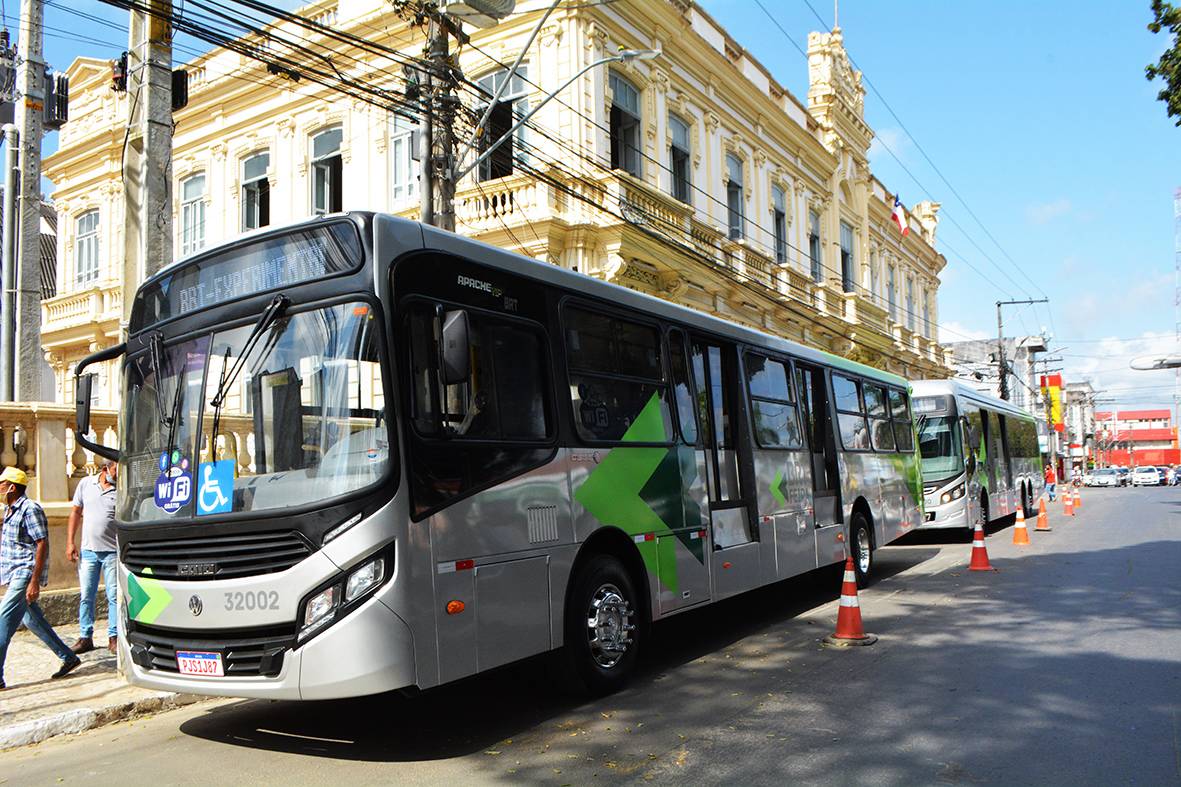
[119,594,416,700]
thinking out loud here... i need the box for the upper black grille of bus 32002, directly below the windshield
[123,531,312,580]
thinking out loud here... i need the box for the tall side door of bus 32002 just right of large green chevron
[692,339,759,599]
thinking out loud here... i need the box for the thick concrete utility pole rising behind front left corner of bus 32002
[123,0,172,325]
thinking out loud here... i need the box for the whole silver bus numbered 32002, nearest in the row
[77,213,921,700]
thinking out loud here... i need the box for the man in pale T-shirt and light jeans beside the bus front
[66,460,119,653]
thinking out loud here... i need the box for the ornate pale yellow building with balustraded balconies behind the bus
[43,0,948,408]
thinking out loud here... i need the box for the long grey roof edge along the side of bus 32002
[410,215,909,390]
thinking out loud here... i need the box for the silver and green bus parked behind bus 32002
[912,379,1045,529]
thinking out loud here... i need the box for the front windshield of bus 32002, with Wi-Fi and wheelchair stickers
[119,301,390,522]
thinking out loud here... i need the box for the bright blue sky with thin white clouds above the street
[13,0,1181,406]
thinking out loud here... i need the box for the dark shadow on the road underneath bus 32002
[181,549,939,761]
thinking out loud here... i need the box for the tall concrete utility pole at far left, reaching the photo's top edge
[6,0,45,402]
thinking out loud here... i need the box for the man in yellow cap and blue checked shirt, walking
[0,467,81,689]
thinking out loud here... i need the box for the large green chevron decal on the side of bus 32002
[574,394,705,593]
